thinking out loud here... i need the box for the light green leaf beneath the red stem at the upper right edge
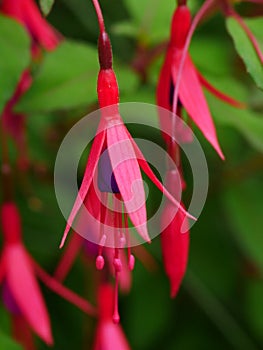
[226,17,263,89]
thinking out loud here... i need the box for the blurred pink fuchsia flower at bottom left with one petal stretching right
[0,202,95,345]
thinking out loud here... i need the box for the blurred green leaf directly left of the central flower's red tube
[16,41,98,113]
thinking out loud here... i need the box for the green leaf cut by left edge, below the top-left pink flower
[0,15,30,114]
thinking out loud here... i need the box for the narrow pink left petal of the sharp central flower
[60,128,105,248]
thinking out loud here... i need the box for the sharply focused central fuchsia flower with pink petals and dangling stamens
[60,23,195,322]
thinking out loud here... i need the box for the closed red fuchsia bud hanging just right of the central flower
[161,170,190,297]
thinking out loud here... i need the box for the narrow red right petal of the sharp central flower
[131,139,196,221]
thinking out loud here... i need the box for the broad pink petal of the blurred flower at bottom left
[4,244,53,345]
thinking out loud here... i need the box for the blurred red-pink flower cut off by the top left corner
[1,0,60,50]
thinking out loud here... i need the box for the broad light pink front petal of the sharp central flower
[107,123,150,242]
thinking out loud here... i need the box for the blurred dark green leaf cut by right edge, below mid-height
[223,178,263,270]
